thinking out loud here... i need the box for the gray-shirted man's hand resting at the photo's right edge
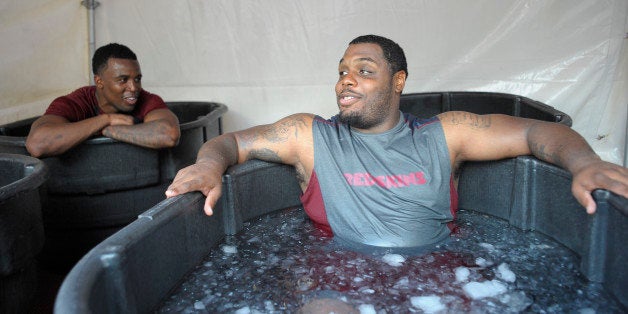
[571,160,628,214]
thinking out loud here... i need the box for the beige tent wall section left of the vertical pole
[0,0,90,124]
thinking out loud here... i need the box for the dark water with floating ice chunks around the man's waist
[157,208,625,313]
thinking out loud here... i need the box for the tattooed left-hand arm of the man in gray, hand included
[166,114,314,215]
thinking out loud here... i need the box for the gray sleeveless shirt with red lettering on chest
[304,113,453,247]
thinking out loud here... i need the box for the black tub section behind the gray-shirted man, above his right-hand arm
[399,92,572,127]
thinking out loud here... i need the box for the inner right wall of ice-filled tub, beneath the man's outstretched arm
[458,156,628,307]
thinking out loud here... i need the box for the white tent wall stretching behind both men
[0,0,628,164]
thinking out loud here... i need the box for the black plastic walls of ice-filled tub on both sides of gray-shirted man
[55,157,628,313]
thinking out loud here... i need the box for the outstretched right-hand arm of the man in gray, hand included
[439,111,628,214]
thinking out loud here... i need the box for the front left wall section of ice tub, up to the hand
[54,193,224,313]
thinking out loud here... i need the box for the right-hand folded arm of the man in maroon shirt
[102,109,181,148]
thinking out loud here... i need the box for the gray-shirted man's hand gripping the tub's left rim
[166,162,223,216]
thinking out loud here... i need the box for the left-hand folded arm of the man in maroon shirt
[26,114,133,158]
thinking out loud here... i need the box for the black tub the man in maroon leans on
[0,102,227,269]
